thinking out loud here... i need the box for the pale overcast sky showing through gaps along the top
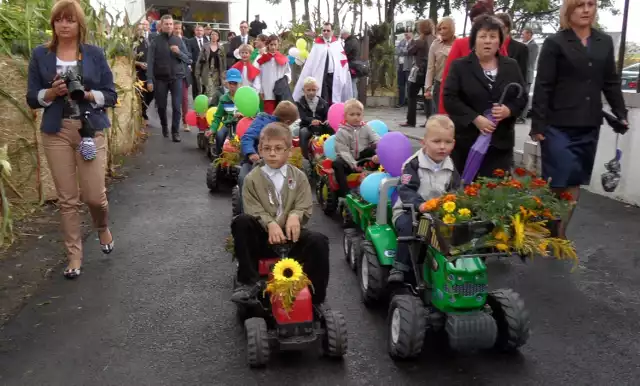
[92,0,640,43]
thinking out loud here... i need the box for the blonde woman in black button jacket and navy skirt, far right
[531,0,627,236]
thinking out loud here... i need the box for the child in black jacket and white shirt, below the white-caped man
[296,77,333,159]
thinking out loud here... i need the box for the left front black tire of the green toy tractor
[387,295,427,360]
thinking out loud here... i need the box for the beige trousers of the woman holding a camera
[42,119,109,260]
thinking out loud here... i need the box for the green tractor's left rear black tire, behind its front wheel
[357,240,389,307]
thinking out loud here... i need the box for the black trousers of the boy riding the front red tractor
[231,214,329,304]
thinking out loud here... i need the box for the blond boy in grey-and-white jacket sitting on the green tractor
[388,115,461,283]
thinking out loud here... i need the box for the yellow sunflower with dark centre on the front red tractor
[264,258,311,313]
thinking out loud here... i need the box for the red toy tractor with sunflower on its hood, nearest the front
[238,244,347,367]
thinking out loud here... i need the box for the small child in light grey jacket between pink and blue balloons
[333,99,380,198]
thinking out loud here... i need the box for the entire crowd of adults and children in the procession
[27,0,628,292]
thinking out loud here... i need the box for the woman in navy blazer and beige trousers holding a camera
[27,0,117,279]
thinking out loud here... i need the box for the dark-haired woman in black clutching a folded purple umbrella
[443,15,527,178]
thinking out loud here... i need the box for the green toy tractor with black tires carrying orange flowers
[343,178,529,359]
